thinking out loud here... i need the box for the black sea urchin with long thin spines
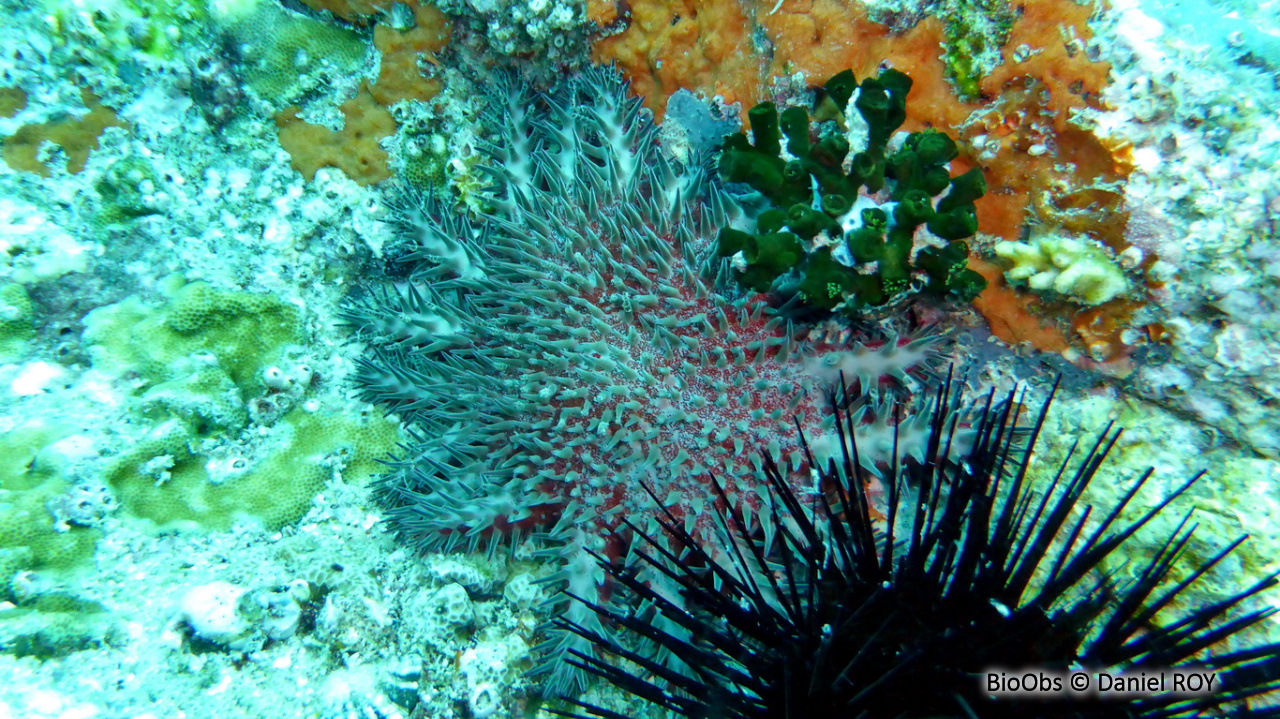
[558,385,1280,719]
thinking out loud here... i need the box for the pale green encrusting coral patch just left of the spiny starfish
[84,277,398,530]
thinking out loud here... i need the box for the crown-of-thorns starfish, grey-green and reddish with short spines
[347,69,938,693]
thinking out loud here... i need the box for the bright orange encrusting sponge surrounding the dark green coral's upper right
[589,0,1130,356]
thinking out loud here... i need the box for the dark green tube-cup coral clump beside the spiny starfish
[719,69,987,312]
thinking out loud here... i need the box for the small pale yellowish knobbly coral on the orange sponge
[995,235,1129,304]
